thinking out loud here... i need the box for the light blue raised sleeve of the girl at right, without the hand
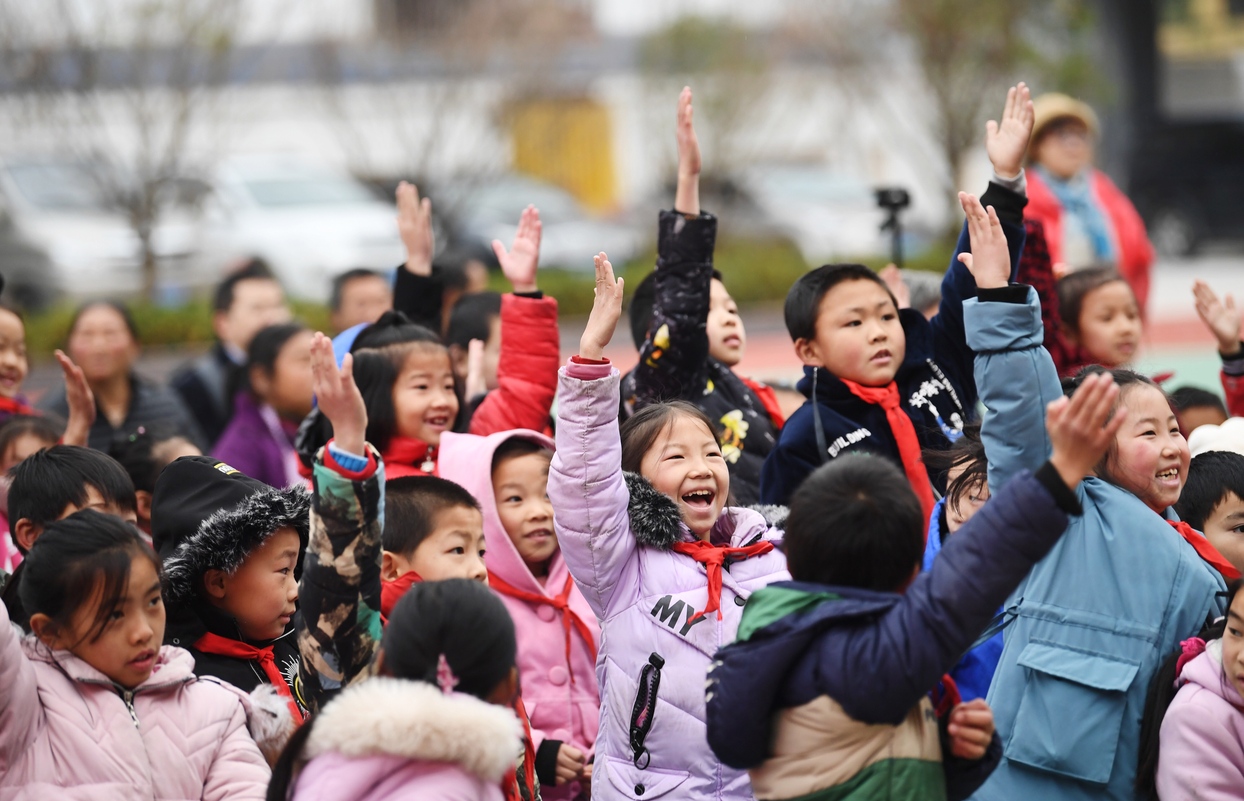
[963,289,1062,493]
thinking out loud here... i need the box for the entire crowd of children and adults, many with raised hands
[0,83,1244,801]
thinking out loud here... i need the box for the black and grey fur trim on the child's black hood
[164,477,311,604]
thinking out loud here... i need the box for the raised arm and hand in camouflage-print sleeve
[297,333,384,709]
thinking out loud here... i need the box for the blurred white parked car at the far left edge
[0,157,203,306]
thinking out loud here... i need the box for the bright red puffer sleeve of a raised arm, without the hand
[469,295,561,437]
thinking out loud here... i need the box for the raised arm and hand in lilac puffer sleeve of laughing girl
[549,254,638,618]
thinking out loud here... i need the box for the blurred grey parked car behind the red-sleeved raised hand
[433,175,646,272]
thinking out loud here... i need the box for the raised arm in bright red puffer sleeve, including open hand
[468,205,561,435]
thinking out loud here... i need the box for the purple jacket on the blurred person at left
[211,392,301,490]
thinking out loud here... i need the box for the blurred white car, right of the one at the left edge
[202,155,406,302]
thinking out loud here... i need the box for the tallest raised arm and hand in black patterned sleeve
[632,87,717,404]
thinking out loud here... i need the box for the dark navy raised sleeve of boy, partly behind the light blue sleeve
[932,183,1028,412]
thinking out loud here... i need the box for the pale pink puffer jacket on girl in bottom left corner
[0,604,270,801]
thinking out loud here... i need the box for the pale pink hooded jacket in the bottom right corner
[1157,639,1244,801]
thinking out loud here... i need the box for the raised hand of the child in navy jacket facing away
[1045,373,1127,489]
